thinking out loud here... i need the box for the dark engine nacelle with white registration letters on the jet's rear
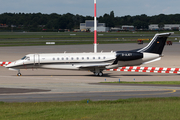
[116,51,143,61]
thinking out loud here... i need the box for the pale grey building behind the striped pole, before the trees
[80,20,109,32]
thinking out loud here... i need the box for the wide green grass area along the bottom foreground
[0,97,180,120]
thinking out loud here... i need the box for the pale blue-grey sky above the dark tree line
[0,0,180,17]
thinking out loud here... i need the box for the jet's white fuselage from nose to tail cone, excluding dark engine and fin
[6,52,160,71]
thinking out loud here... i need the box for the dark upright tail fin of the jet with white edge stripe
[137,33,173,55]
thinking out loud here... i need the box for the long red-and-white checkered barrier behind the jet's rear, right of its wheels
[107,66,180,74]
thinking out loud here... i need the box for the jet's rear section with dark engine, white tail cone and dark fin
[112,33,173,67]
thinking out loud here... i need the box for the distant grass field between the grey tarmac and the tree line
[0,32,180,46]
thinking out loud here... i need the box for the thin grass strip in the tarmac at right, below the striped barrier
[101,81,180,85]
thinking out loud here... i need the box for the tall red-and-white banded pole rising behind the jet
[94,0,97,53]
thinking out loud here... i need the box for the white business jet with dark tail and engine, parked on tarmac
[2,33,173,76]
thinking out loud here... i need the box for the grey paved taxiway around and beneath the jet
[0,43,180,102]
